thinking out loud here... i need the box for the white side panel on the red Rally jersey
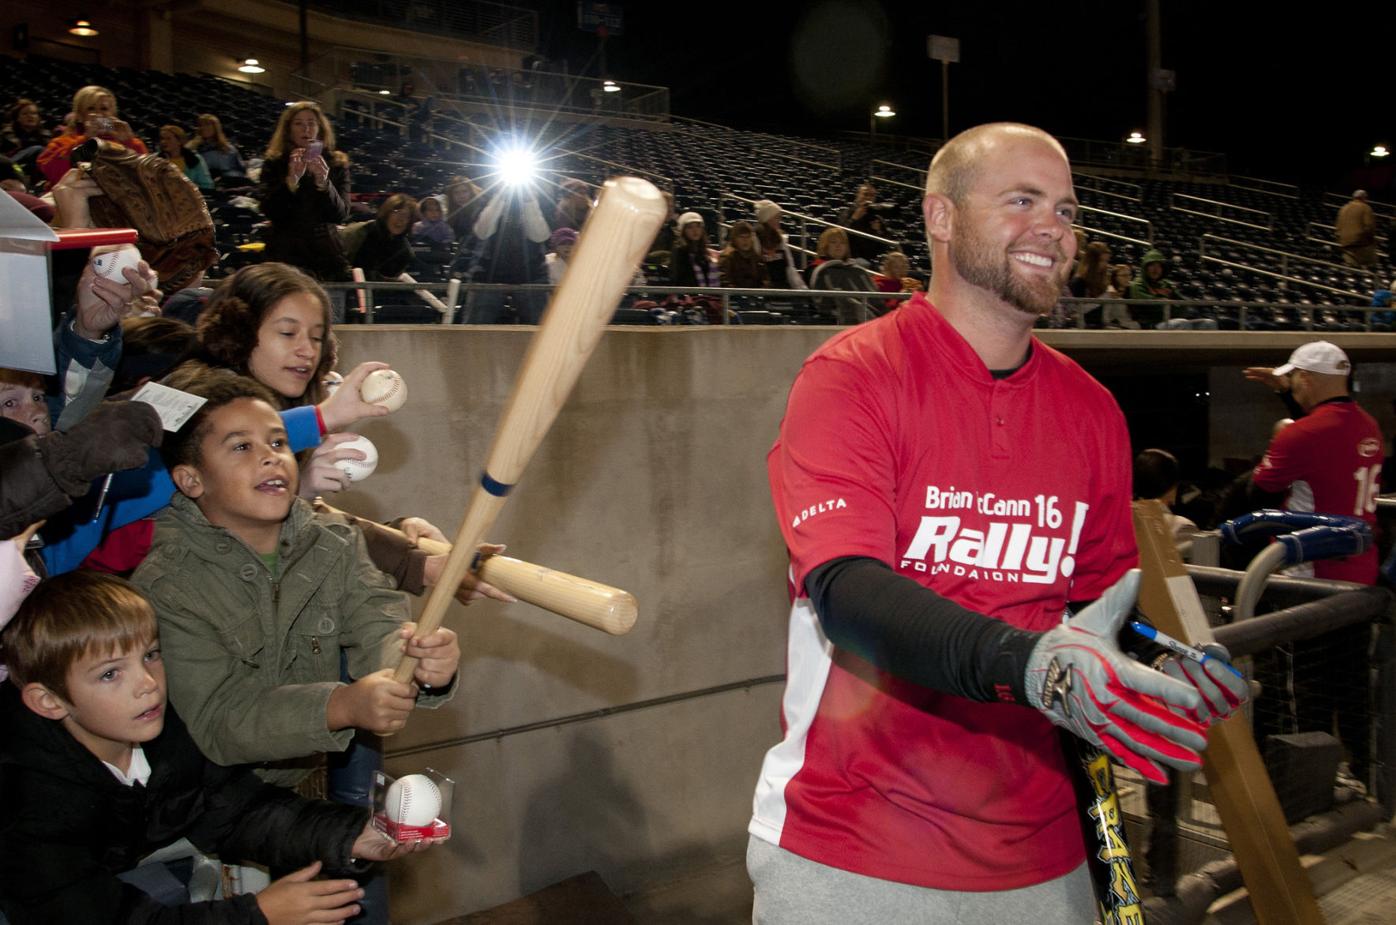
[747,597,833,845]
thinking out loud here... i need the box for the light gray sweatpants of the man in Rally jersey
[747,836,1096,925]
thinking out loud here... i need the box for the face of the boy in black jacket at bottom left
[59,638,165,770]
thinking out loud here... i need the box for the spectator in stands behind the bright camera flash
[458,186,550,325]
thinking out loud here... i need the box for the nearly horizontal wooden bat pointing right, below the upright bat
[417,540,638,636]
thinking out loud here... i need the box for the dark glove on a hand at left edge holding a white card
[39,402,165,497]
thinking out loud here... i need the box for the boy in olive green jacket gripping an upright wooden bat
[133,370,461,785]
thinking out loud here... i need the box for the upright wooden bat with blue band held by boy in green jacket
[394,177,667,682]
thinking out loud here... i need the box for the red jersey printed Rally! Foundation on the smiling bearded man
[750,293,1136,890]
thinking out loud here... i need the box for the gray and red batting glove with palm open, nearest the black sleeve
[1025,569,1208,784]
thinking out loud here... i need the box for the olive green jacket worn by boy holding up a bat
[131,494,455,785]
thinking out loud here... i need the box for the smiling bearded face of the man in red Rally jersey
[949,135,1076,315]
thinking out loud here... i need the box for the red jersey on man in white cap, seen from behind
[1252,396,1382,585]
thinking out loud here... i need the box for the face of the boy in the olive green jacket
[170,398,299,552]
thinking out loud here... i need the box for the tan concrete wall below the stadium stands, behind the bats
[339,326,1396,925]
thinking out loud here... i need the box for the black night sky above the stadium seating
[517,0,1396,198]
